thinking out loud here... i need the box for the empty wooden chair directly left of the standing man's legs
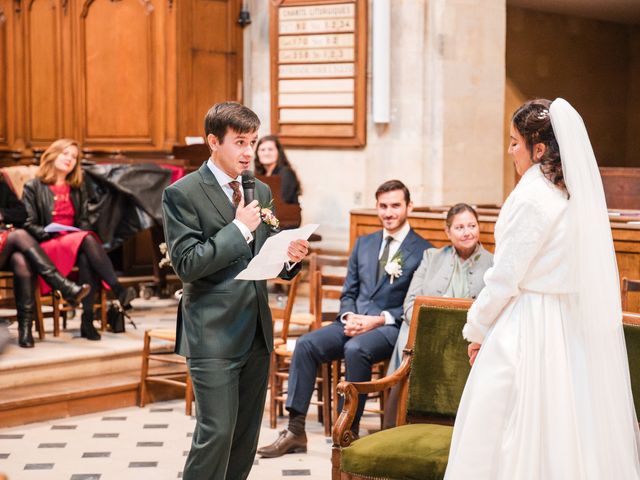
[138,329,193,416]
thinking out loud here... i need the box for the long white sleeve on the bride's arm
[462,199,551,343]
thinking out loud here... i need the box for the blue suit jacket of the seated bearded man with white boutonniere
[338,229,432,343]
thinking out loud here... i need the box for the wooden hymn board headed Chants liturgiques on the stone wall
[270,0,367,147]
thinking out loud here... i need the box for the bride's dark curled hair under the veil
[511,98,567,191]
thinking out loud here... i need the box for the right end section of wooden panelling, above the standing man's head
[178,0,243,143]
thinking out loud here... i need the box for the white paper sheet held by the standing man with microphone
[236,223,319,280]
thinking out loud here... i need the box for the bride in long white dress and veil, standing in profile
[445,99,640,480]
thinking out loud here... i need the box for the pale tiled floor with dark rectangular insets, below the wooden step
[0,400,344,480]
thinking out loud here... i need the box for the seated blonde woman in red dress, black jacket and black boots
[23,139,133,340]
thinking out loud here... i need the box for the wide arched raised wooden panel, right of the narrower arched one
[77,0,163,149]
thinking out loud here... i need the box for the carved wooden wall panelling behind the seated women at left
[0,0,242,159]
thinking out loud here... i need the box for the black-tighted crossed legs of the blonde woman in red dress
[77,235,122,318]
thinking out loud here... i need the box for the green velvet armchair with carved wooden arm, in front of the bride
[331,297,471,480]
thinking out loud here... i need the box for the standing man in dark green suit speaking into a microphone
[162,103,309,480]
